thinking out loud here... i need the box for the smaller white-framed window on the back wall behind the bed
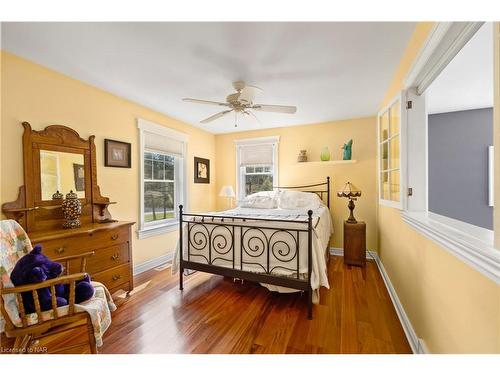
[236,137,279,199]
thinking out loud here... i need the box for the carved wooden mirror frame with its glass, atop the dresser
[2,122,114,232]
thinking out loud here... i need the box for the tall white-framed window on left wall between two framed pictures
[138,119,187,238]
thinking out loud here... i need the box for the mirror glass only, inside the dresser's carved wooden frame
[40,150,85,201]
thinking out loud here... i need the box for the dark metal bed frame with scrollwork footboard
[179,177,330,319]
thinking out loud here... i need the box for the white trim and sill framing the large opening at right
[401,22,500,284]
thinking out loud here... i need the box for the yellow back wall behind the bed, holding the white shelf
[215,117,377,250]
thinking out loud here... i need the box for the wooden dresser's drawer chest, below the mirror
[29,221,134,293]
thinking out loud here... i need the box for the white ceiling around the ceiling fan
[2,22,415,133]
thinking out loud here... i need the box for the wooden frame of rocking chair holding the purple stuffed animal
[0,252,97,354]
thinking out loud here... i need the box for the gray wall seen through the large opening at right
[428,108,493,229]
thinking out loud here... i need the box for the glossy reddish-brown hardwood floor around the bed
[0,257,411,353]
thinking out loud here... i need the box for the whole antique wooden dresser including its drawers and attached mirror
[2,122,134,292]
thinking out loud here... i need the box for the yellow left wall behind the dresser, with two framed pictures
[0,52,216,264]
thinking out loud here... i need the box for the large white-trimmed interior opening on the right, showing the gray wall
[401,22,500,283]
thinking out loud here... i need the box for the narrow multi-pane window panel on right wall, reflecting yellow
[378,96,403,208]
